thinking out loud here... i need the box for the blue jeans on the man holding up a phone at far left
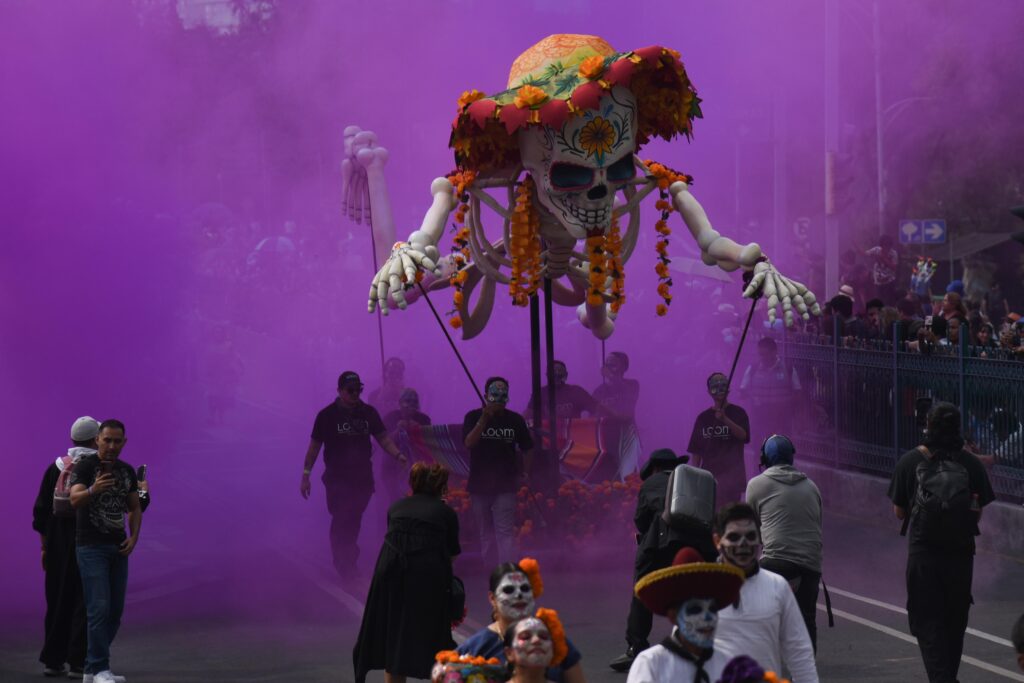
[77,544,128,674]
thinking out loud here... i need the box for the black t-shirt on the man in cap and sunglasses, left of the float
[311,400,387,482]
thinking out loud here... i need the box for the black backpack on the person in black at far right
[910,447,977,548]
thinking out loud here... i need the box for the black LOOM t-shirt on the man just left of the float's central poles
[462,408,534,496]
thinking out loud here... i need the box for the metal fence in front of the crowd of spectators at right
[775,323,1024,502]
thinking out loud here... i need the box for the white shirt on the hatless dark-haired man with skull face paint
[715,568,818,683]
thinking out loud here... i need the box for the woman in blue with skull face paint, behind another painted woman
[458,558,586,683]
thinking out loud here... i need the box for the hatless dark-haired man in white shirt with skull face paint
[714,503,818,683]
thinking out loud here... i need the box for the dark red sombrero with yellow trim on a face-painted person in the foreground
[635,548,743,615]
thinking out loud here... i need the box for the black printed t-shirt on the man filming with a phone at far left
[70,456,138,546]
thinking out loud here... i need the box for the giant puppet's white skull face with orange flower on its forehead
[519,86,637,240]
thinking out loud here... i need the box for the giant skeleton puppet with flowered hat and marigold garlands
[362,35,819,339]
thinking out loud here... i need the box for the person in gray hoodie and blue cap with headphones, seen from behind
[746,434,821,652]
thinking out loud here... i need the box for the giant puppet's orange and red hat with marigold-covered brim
[449,34,701,173]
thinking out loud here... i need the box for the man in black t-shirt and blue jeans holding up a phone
[71,420,142,683]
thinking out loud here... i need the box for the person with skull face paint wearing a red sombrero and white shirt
[627,548,743,683]
